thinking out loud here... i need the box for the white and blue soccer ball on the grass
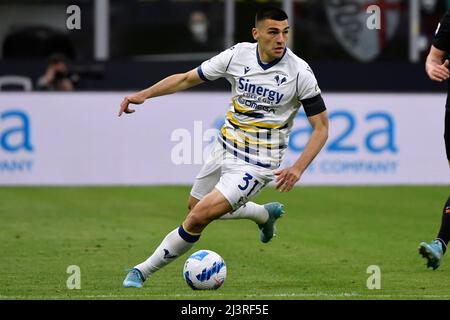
[183,250,227,290]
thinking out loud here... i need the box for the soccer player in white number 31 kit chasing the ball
[119,7,328,288]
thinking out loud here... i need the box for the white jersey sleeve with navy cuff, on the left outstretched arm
[197,46,237,81]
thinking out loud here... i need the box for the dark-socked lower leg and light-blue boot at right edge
[419,197,450,270]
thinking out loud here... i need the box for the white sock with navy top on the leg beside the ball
[135,226,200,279]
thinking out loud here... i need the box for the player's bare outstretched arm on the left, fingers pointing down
[119,69,203,117]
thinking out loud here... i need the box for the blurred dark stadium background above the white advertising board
[0,0,450,92]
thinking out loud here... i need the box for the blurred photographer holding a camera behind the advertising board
[36,54,74,91]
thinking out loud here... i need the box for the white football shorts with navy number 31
[191,142,275,210]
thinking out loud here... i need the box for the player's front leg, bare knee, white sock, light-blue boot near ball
[123,189,231,288]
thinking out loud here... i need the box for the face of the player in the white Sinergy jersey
[252,19,289,62]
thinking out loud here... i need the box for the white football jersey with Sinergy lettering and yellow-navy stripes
[197,42,321,169]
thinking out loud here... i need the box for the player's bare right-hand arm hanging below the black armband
[275,111,328,192]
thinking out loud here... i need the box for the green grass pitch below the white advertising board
[0,186,450,300]
